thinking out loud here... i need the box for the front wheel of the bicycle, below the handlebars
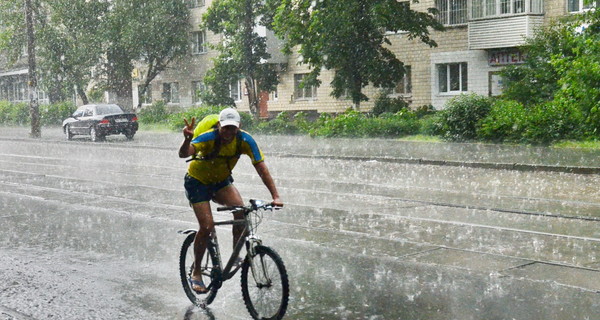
[241,246,289,320]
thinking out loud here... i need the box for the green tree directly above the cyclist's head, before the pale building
[202,0,278,118]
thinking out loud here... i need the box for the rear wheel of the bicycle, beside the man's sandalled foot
[179,232,220,306]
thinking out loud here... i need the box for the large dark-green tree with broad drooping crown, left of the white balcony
[268,0,443,109]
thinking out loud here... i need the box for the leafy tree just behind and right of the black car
[94,0,190,109]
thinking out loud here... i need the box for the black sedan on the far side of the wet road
[63,104,138,142]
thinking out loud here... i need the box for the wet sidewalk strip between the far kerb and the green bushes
[0,127,600,174]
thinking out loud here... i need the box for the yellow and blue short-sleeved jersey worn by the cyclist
[188,130,264,184]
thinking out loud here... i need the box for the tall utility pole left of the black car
[25,0,42,138]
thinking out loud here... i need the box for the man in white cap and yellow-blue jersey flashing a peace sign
[179,108,283,293]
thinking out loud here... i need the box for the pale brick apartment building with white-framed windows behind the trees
[0,0,590,112]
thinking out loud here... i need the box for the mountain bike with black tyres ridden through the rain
[179,199,289,319]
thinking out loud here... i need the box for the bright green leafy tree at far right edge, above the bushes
[502,10,600,136]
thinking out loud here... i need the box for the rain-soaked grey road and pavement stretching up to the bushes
[0,128,600,320]
